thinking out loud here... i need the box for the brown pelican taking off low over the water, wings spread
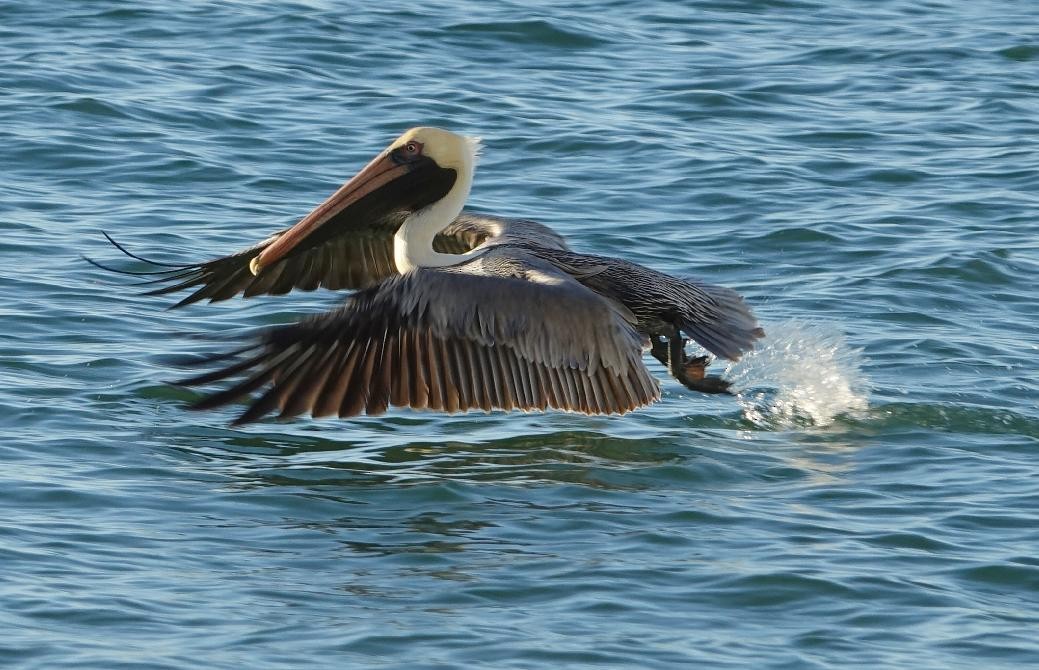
[97,128,765,424]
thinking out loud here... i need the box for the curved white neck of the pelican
[393,136,482,274]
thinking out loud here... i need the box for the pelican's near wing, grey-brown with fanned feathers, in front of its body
[182,250,660,424]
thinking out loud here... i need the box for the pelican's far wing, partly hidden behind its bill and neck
[87,214,566,307]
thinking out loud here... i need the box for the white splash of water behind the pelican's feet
[724,320,870,429]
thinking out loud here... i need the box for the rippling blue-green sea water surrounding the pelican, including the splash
[0,0,1039,669]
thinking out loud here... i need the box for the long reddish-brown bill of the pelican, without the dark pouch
[249,149,408,275]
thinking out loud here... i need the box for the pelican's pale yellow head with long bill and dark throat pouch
[249,128,479,275]
